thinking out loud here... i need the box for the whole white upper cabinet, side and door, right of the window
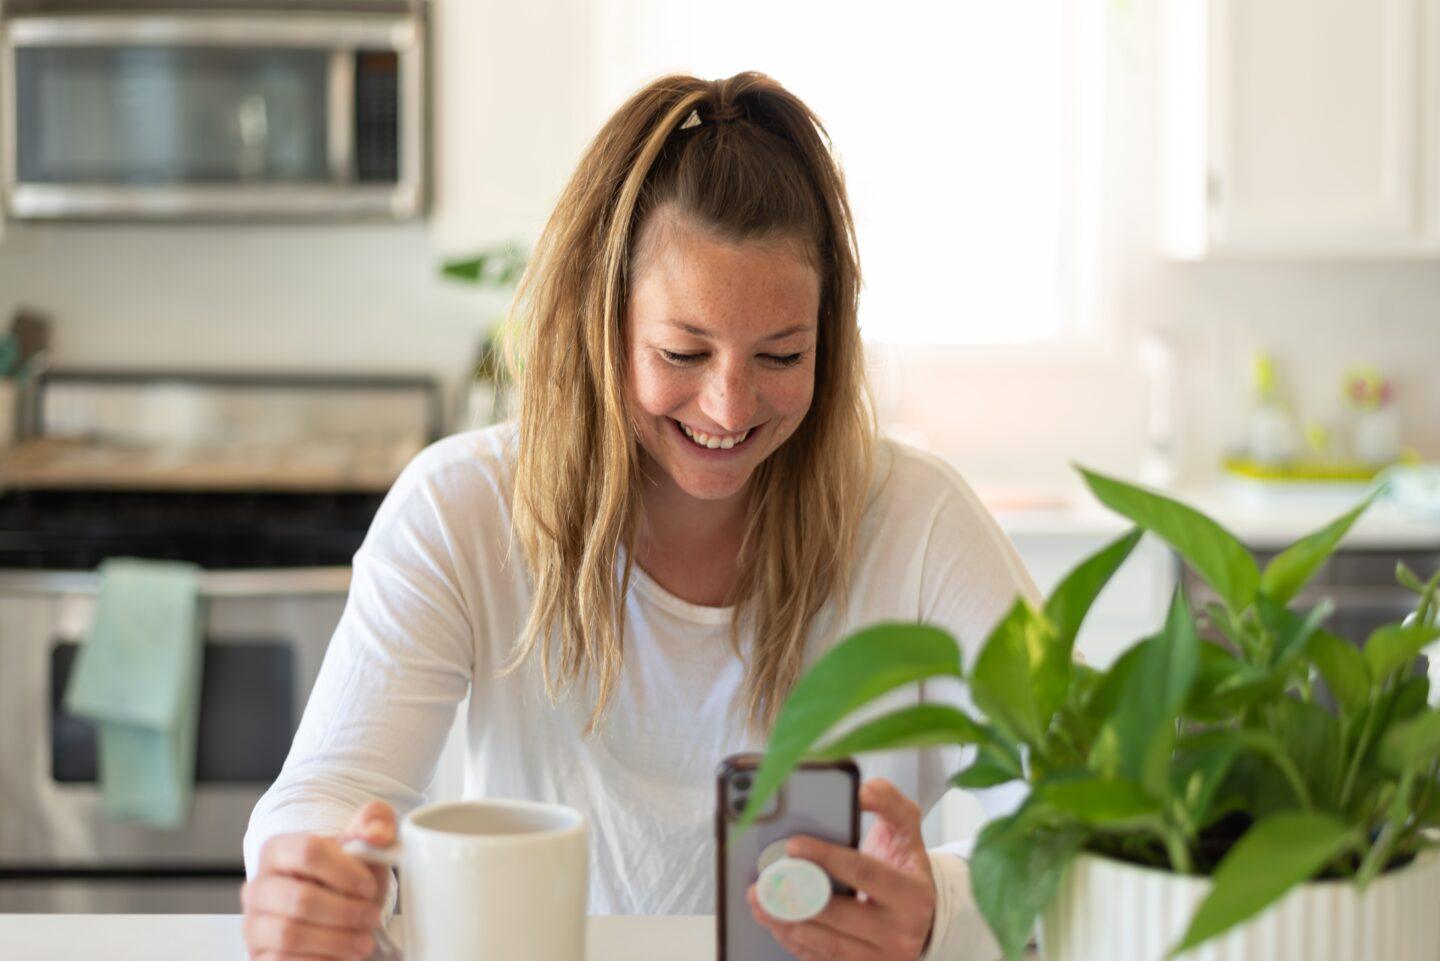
[1161,0,1440,259]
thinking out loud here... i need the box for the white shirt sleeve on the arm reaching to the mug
[245,465,475,877]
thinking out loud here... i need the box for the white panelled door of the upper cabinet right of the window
[1208,0,1423,254]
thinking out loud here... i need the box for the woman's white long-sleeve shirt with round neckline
[245,425,1038,958]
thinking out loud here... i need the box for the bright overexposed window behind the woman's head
[592,0,1103,344]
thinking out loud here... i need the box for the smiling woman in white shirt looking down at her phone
[243,73,1034,960]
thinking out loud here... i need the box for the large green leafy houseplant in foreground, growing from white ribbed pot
[749,471,1440,961]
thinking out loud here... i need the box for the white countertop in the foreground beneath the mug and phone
[0,915,1025,961]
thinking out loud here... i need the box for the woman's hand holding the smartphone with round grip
[749,778,935,961]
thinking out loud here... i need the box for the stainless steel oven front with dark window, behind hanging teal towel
[0,568,350,913]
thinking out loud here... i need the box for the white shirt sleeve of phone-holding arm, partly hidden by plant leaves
[917,471,1043,961]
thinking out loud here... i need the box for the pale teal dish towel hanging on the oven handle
[65,558,202,830]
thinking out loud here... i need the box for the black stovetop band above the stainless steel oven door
[0,490,383,571]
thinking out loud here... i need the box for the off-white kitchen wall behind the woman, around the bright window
[0,0,1440,481]
